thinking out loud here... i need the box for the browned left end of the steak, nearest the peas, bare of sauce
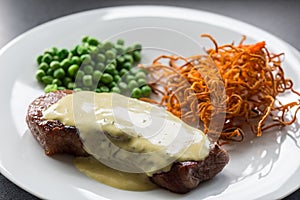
[26,90,88,156]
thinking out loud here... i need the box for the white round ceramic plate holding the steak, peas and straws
[0,6,300,200]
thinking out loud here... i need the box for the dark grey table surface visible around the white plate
[0,0,300,200]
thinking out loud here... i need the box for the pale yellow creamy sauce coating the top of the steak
[43,91,209,190]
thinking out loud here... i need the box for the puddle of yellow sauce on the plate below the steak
[74,156,157,191]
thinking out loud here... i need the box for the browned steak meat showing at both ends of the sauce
[26,90,229,193]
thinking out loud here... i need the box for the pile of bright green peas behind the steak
[35,36,152,98]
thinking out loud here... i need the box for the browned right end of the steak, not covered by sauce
[151,145,229,194]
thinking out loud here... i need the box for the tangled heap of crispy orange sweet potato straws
[142,34,300,141]
